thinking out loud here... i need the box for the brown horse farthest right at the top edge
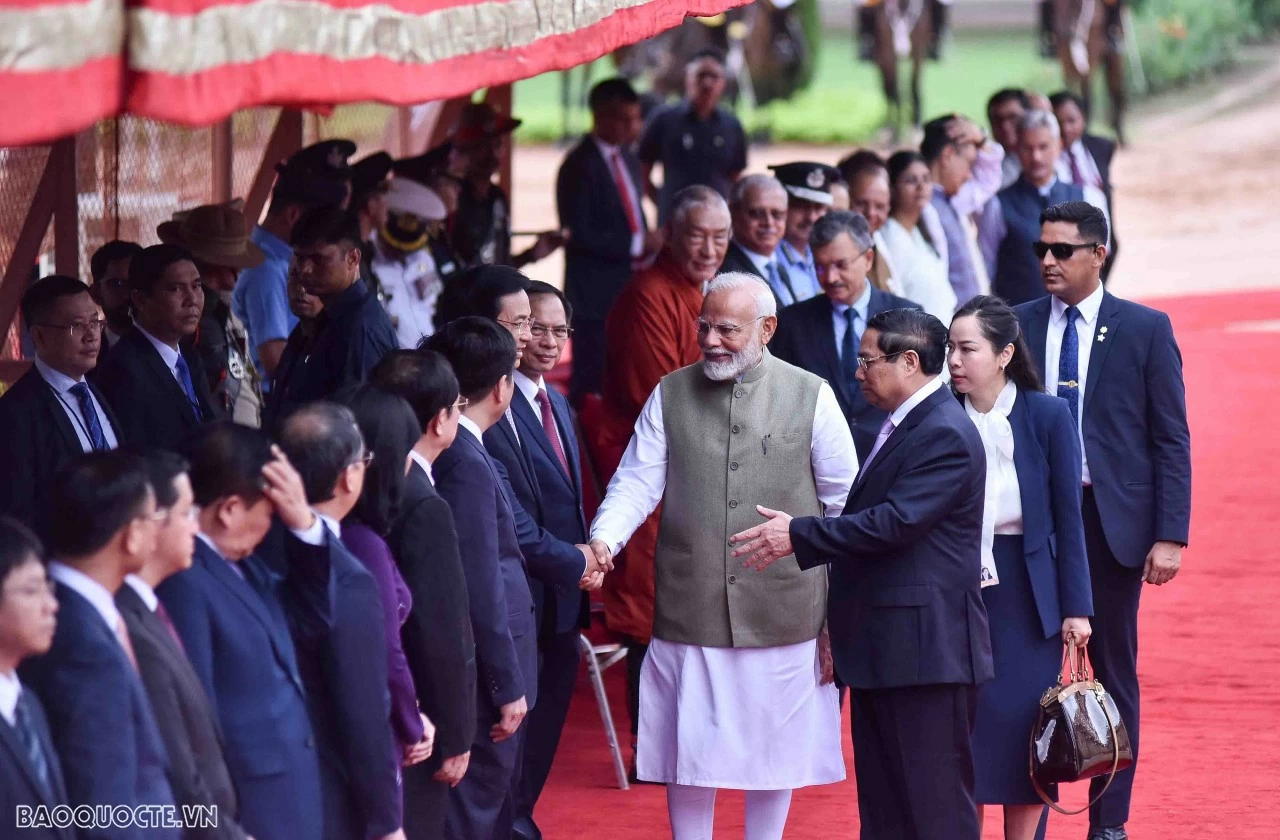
[1053,0,1128,146]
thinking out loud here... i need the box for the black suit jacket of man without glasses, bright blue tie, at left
[92,329,225,451]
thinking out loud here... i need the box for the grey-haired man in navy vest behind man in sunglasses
[978,110,1111,306]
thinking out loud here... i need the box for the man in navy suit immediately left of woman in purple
[280,402,404,840]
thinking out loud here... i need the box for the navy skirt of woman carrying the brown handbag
[973,535,1062,805]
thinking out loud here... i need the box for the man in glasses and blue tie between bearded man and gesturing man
[769,210,920,462]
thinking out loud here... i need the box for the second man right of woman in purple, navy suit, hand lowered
[428,316,538,840]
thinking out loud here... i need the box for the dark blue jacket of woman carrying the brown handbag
[1009,391,1093,639]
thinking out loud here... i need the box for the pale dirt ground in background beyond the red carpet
[513,64,1280,298]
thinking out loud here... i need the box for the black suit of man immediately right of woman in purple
[387,464,476,840]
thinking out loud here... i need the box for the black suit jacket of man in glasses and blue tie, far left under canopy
[0,368,120,530]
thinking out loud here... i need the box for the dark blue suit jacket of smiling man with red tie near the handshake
[484,387,586,634]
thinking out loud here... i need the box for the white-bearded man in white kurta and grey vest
[591,273,858,840]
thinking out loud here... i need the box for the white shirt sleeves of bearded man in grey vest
[591,383,858,554]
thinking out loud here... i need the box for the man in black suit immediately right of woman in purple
[370,350,476,840]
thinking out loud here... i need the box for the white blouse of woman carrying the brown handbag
[964,382,1023,586]
